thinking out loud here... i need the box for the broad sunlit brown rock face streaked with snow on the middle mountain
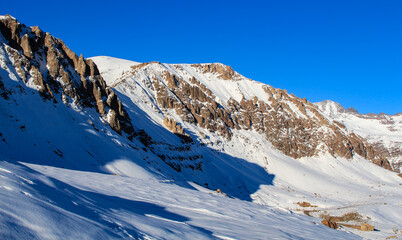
[117,62,391,169]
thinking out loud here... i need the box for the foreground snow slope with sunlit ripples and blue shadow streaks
[0,157,359,239]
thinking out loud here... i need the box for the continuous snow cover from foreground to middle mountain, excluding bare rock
[0,49,402,239]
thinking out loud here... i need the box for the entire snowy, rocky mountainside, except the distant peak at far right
[0,16,402,239]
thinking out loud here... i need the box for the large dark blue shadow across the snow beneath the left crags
[0,73,275,201]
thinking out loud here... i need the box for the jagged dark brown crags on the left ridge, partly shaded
[0,16,134,137]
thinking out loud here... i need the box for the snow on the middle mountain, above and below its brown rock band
[94,56,402,239]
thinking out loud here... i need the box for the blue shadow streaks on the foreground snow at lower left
[0,163,213,239]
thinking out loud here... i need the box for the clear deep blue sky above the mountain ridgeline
[0,0,402,114]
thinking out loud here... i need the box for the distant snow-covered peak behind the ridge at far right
[315,100,402,172]
